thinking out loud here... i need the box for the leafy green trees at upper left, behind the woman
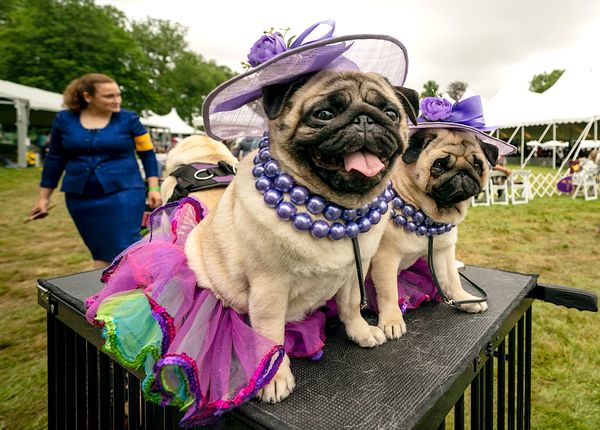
[0,0,234,119]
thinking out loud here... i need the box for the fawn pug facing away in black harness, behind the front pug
[160,135,238,211]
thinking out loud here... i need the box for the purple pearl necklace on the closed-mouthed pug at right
[390,188,456,237]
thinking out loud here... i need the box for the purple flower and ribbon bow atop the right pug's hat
[417,96,495,131]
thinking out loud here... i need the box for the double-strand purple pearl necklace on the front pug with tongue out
[252,132,395,240]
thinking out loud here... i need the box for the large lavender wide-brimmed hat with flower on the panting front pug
[202,21,408,140]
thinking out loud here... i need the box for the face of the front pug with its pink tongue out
[263,71,418,205]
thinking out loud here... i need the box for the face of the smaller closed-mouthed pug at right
[402,128,498,210]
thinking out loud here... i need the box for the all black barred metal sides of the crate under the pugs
[47,307,531,430]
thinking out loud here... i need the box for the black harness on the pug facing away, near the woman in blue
[169,161,236,203]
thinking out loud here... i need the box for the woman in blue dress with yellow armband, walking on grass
[31,73,161,268]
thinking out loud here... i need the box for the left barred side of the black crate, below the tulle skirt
[47,313,186,430]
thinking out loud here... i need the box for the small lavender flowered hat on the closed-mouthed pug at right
[410,96,517,155]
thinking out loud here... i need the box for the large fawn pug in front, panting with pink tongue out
[185,70,418,402]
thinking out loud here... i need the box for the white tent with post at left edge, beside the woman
[0,80,63,167]
